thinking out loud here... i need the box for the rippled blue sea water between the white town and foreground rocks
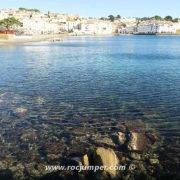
[0,36,180,174]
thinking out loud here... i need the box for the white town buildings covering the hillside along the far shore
[0,9,180,35]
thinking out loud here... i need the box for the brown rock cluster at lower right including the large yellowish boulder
[50,122,161,180]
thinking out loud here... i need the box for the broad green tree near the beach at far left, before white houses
[0,17,23,30]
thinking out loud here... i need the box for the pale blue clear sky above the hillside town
[0,0,180,17]
